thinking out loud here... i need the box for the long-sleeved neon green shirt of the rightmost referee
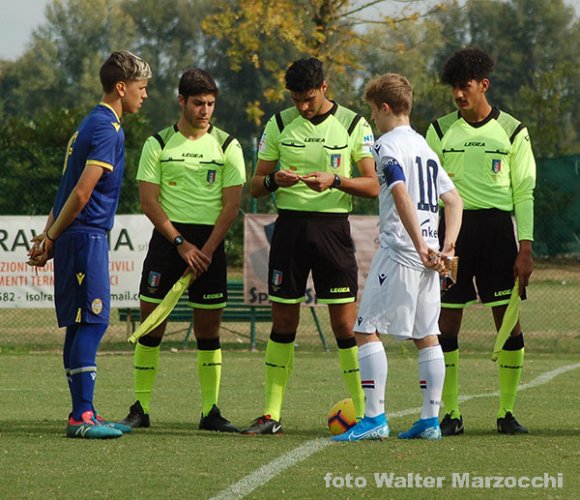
[427,108,536,241]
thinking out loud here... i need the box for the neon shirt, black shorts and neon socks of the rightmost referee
[427,108,536,419]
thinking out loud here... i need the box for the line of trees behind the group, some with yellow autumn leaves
[0,0,580,240]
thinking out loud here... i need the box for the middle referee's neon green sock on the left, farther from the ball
[264,339,294,420]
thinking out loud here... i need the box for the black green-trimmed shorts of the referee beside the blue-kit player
[139,222,228,309]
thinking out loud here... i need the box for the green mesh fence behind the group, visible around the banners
[0,151,580,353]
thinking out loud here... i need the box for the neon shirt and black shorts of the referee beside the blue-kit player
[137,125,246,309]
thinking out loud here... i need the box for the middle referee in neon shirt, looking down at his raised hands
[243,58,379,434]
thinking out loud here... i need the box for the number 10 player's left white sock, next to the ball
[358,341,387,418]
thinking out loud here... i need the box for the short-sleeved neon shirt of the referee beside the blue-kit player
[137,125,246,226]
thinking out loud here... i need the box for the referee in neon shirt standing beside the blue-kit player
[123,68,246,432]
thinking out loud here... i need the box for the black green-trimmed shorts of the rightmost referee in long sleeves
[439,208,518,308]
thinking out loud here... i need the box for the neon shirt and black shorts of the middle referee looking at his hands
[258,104,374,304]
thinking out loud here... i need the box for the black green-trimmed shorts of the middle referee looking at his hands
[268,210,358,304]
